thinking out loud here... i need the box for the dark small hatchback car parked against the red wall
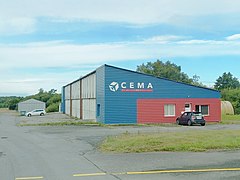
[176,112,206,126]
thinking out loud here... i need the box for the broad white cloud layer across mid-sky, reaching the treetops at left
[0,36,240,95]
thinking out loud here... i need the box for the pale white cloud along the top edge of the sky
[0,0,240,33]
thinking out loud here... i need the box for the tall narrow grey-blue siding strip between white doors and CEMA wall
[96,66,105,123]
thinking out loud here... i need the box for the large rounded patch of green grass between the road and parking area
[99,130,240,153]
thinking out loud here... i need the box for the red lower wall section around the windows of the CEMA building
[137,98,221,124]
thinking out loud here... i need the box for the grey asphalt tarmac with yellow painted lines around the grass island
[0,112,240,180]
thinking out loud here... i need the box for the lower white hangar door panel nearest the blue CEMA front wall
[83,99,96,120]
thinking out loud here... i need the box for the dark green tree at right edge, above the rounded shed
[214,72,240,90]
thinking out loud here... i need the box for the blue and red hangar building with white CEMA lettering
[62,64,221,124]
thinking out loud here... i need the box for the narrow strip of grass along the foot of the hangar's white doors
[18,121,102,126]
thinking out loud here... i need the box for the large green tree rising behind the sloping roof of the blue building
[137,60,193,84]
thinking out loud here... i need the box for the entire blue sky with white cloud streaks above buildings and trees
[0,0,240,96]
